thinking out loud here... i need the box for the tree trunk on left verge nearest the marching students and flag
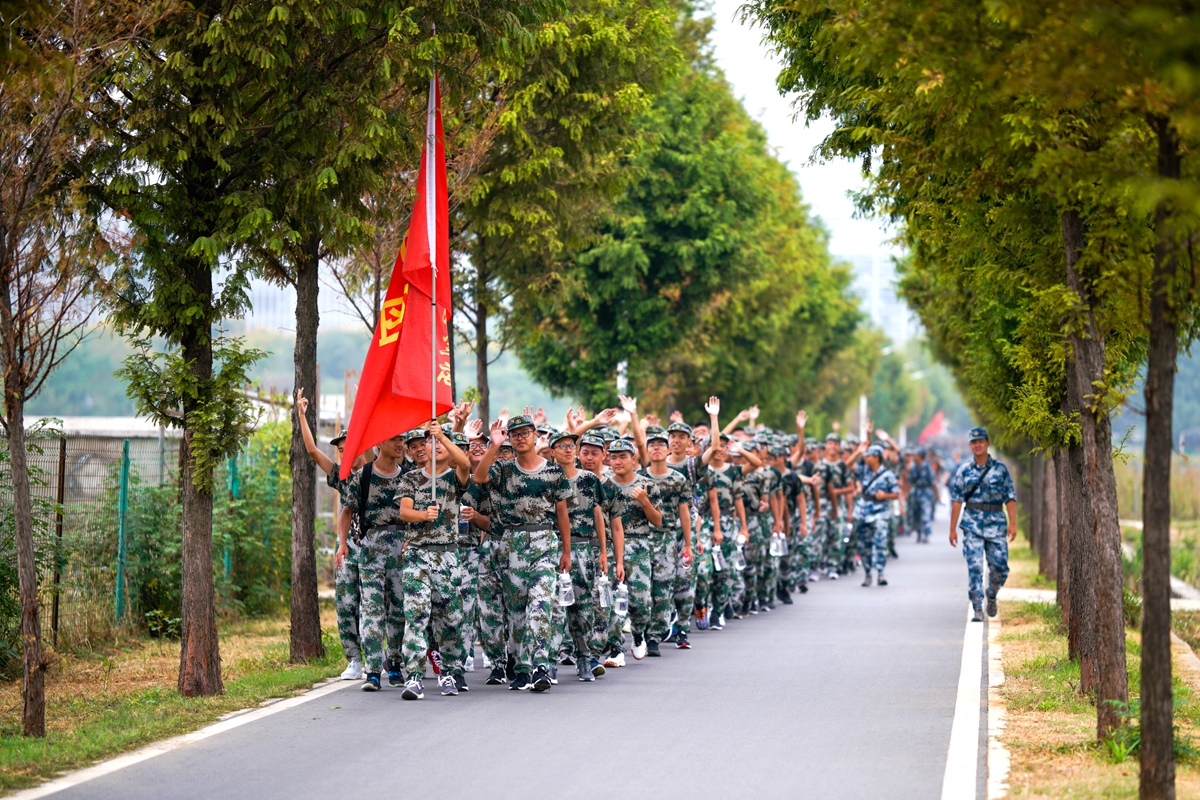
[288,236,325,663]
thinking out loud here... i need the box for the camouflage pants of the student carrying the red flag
[402,547,463,676]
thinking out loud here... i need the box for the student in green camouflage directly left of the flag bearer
[338,434,404,692]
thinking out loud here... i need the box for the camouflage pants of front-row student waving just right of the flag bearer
[498,529,562,674]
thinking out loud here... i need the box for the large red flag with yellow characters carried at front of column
[340,76,451,480]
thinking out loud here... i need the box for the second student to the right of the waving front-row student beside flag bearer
[607,439,662,660]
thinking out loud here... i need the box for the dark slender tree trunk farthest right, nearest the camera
[1139,118,1180,800]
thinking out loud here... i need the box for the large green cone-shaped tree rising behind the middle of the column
[516,12,857,425]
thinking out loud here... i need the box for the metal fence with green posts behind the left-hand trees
[0,431,336,648]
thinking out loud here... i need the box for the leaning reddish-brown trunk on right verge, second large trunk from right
[1062,211,1129,736]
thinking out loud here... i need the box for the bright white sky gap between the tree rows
[712,0,894,255]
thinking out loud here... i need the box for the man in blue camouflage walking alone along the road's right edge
[950,427,1016,622]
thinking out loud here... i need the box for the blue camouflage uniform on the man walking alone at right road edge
[950,456,1016,609]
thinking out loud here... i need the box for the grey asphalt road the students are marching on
[46,524,966,800]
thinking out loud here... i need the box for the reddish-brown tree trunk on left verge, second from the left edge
[179,293,224,697]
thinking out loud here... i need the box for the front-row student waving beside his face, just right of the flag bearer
[474,414,571,692]
